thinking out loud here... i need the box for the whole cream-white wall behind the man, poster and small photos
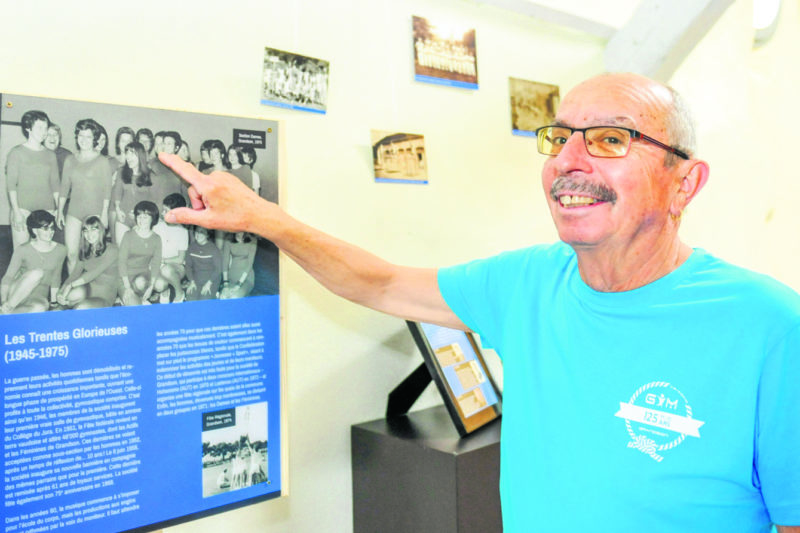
[0,0,800,533]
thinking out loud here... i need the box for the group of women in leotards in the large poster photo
[0,111,260,314]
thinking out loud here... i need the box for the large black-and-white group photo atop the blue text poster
[0,94,278,314]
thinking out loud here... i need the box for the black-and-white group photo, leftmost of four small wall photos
[261,48,330,114]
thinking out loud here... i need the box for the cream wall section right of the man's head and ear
[671,0,800,284]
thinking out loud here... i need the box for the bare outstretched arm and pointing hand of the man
[159,153,468,329]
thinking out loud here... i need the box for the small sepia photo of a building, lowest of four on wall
[370,130,428,185]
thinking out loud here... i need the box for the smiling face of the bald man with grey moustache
[542,77,680,251]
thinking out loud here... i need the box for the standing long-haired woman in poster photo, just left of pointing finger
[111,141,156,244]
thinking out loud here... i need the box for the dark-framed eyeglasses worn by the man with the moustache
[536,126,689,159]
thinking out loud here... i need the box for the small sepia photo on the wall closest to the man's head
[508,78,560,137]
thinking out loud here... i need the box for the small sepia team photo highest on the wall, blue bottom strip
[412,16,478,89]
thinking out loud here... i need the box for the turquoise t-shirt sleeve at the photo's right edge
[755,325,800,526]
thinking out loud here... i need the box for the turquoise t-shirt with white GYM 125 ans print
[439,243,800,533]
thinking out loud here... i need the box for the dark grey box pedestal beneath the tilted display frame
[350,406,502,533]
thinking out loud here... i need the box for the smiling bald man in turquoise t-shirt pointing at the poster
[163,74,800,533]
